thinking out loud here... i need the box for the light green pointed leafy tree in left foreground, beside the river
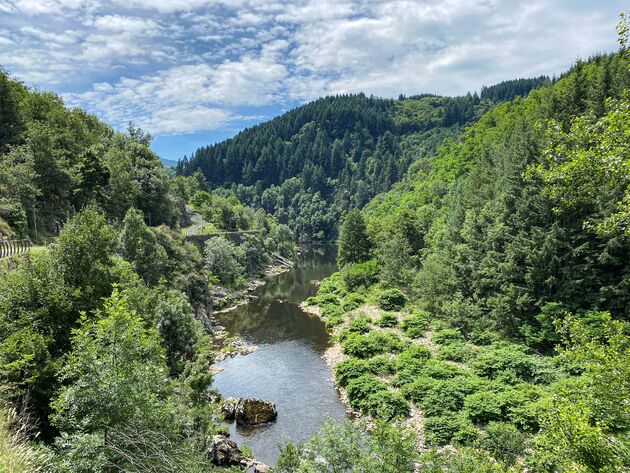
[53,291,168,433]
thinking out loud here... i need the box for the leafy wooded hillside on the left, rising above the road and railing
[0,71,176,239]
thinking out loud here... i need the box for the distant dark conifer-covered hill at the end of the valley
[176,94,491,240]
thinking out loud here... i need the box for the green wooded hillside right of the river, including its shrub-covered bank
[296,45,630,472]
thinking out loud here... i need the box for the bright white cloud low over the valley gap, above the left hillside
[65,43,287,134]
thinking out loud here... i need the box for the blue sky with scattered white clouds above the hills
[0,0,628,160]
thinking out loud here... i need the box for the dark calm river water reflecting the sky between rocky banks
[212,249,345,465]
